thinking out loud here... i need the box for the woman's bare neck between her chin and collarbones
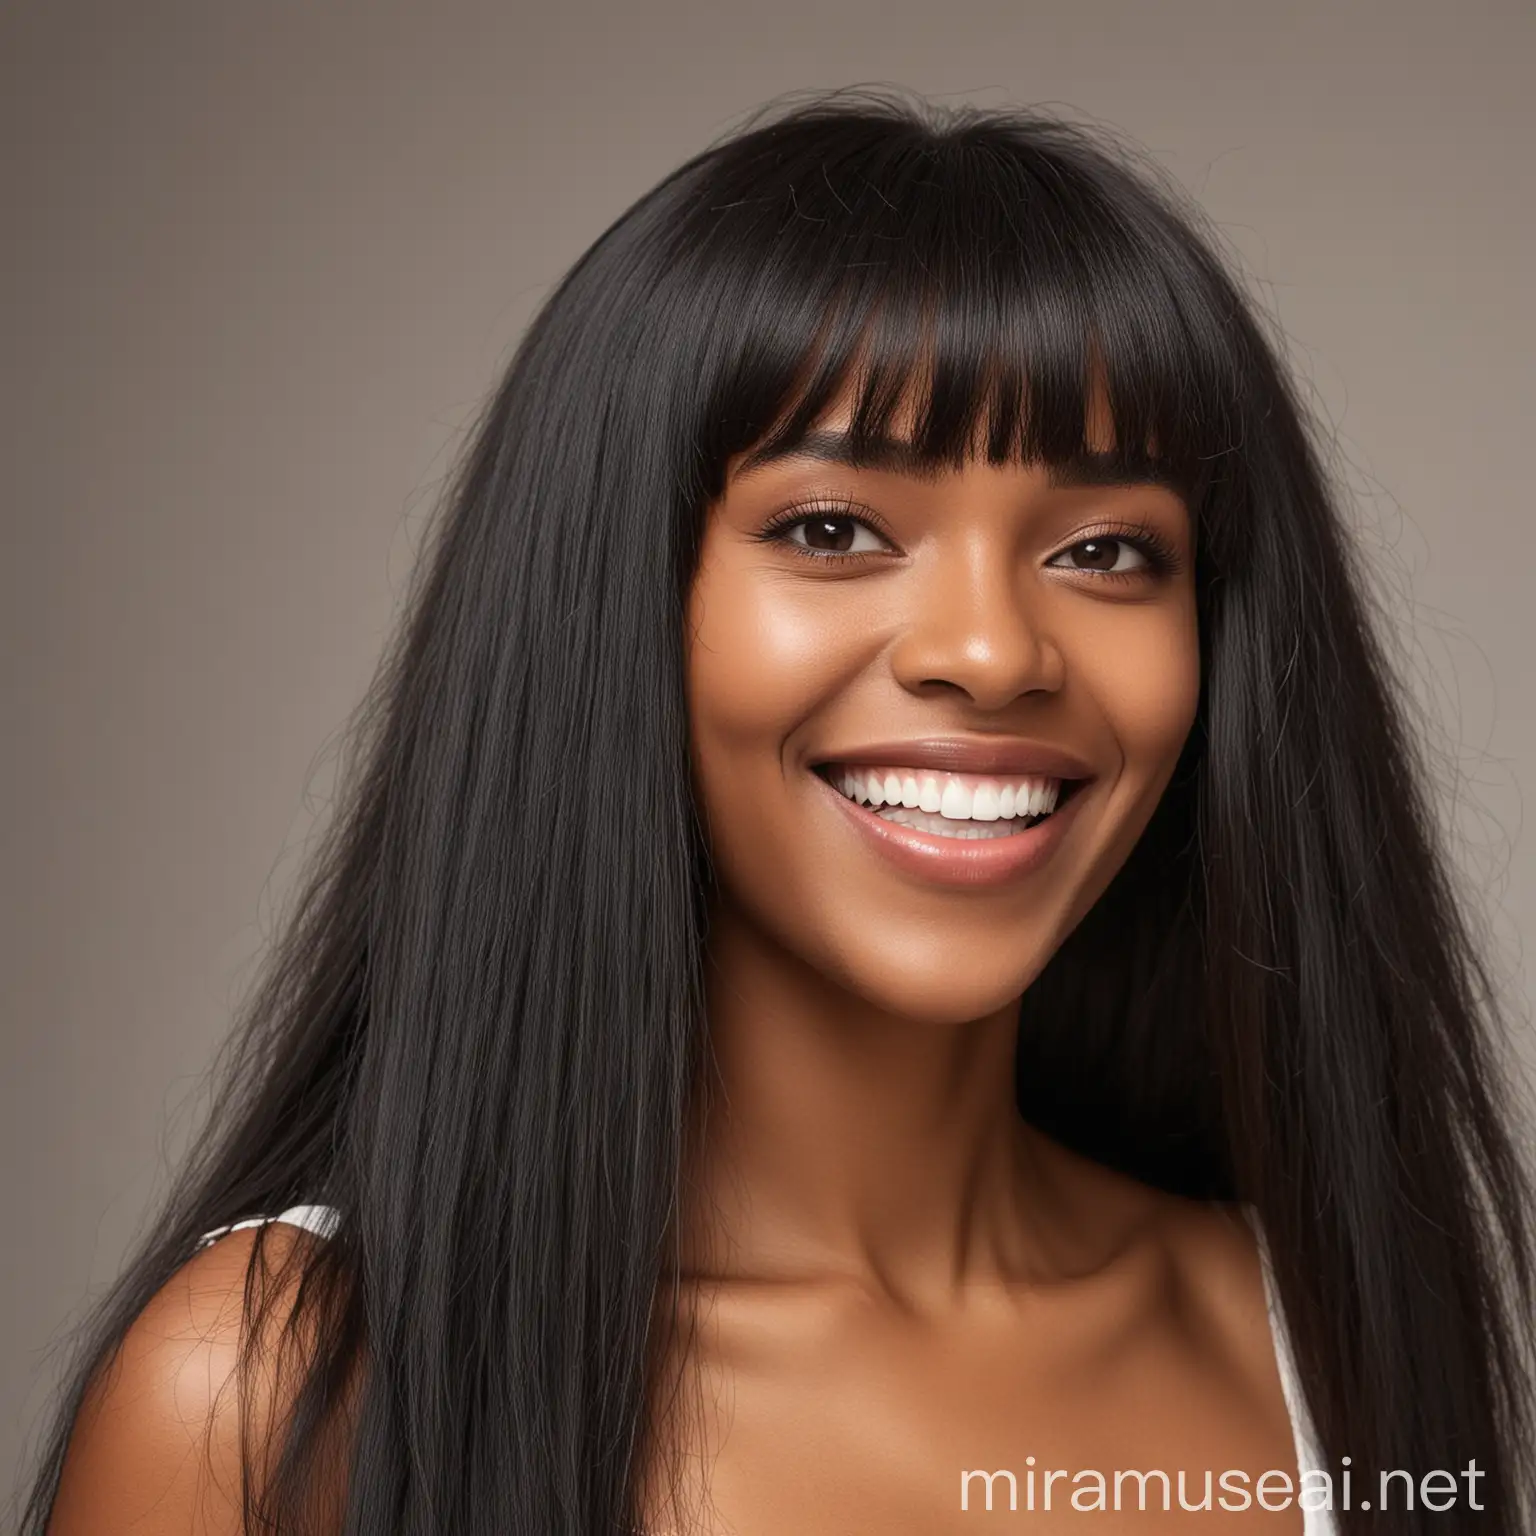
[684,912,1075,1295]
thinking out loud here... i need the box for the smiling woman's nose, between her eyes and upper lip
[891,548,1064,711]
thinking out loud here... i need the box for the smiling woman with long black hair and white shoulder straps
[29,97,1533,1536]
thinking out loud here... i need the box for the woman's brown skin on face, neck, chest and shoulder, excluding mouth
[51,393,1301,1536]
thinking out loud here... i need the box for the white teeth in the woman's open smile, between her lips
[814,762,1087,840]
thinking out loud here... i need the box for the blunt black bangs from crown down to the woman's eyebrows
[677,106,1243,510]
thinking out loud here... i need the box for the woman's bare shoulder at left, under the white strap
[49,1226,336,1536]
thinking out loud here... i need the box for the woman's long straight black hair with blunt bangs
[29,94,1536,1536]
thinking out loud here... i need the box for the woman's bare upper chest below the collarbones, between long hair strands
[642,1312,1303,1536]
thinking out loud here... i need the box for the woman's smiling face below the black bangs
[688,390,1200,1021]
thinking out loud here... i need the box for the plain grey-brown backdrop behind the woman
[0,0,1536,1493]
